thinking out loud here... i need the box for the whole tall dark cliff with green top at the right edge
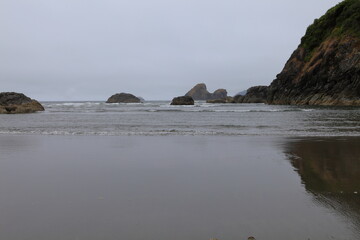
[267,0,360,105]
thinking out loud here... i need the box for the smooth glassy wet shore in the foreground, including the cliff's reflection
[0,136,360,240]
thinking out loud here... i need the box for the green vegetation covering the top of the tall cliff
[300,0,360,60]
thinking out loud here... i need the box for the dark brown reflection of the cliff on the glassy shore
[285,138,360,230]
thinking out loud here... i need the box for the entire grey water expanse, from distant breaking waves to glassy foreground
[0,101,360,240]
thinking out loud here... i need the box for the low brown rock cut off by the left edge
[0,92,45,114]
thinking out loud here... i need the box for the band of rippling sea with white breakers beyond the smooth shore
[0,101,360,136]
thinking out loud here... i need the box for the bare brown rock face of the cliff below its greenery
[268,37,360,105]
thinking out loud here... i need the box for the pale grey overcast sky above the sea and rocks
[0,0,339,101]
